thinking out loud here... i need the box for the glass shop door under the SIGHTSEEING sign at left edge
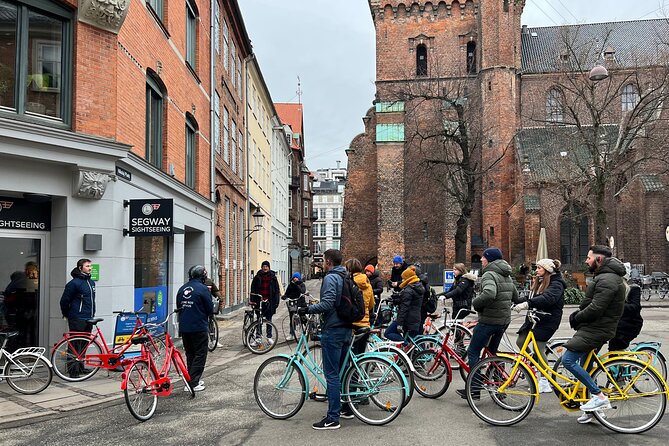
[0,233,44,351]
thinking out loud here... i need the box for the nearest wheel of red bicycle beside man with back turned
[123,361,158,421]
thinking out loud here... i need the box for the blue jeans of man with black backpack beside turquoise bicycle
[321,327,351,421]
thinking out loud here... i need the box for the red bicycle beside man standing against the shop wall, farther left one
[51,311,165,382]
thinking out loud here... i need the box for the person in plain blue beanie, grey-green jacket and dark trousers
[456,247,518,399]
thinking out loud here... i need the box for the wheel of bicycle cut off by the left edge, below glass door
[3,354,53,395]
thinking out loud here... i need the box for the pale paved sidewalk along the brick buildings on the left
[0,280,320,430]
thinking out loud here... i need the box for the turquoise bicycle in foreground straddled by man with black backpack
[253,318,410,426]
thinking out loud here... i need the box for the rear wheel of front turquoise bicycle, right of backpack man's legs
[342,357,408,426]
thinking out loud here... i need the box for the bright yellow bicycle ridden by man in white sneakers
[465,309,669,434]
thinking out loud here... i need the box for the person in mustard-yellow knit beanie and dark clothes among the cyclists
[384,266,425,342]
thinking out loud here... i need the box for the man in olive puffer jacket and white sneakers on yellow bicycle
[562,245,626,420]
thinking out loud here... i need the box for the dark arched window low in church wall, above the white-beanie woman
[560,205,590,266]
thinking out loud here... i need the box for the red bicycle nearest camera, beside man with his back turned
[121,309,195,421]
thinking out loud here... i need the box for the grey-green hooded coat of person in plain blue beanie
[472,259,518,326]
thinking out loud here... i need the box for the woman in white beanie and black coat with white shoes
[514,259,567,393]
